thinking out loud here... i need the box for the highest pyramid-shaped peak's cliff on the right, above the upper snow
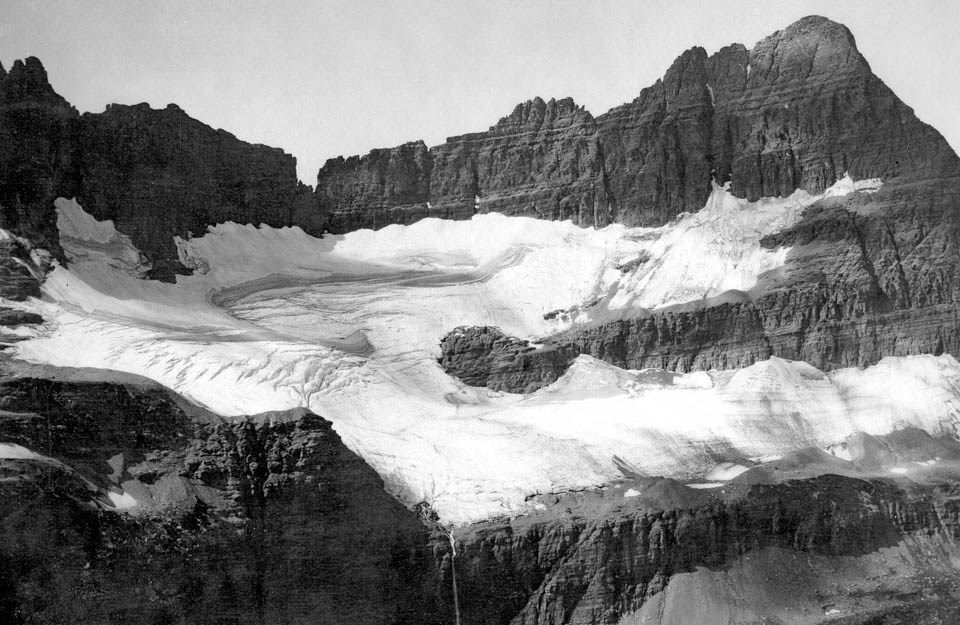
[597,17,957,226]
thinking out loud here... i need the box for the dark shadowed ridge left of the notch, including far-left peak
[0,57,323,286]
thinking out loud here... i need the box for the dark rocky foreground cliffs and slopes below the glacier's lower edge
[0,361,960,624]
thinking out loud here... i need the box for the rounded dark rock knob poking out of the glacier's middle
[438,326,573,393]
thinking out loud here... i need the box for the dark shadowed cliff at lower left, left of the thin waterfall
[0,369,442,624]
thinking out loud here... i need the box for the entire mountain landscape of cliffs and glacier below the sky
[0,16,960,625]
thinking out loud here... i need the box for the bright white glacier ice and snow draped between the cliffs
[16,179,960,523]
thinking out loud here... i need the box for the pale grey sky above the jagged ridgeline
[0,0,960,184]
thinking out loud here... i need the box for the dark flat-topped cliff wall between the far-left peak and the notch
[73,104,323,277]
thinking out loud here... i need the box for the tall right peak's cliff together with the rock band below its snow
[408,17,960,377]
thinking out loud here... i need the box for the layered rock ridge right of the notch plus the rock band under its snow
[328,17,960,376]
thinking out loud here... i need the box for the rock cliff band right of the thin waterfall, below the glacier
[436,475,960,625]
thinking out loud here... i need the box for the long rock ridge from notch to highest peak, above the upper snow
[317,17,958,232]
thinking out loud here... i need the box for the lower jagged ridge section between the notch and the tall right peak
[317,98,611,232]
